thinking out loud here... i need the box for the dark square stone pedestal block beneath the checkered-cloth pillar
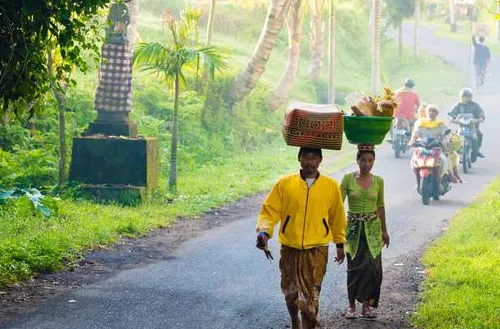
[69,136,159,200]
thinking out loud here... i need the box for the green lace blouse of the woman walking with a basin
[340,172,384,259]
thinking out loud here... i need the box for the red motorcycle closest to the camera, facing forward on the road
[412,138,451,205]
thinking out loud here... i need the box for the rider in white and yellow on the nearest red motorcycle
[408,104,448,191]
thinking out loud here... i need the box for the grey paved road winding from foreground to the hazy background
[3,24,500,329]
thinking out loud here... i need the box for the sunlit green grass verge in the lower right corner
[413,179,500,329]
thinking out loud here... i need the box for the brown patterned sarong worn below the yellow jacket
[280,245,328,325]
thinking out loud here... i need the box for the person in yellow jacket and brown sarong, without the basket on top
[257,148,346,329]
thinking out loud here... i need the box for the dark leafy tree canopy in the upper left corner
[0,0,111,117]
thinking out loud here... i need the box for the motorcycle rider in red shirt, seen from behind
[391,78,420,142]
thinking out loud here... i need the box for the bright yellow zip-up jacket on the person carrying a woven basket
[257,173,346,250]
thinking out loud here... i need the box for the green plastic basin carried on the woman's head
[344,116,393,144]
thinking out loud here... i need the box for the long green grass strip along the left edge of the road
[0,140,354,287]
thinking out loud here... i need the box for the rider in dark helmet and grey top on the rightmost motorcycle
[448,88,486,158]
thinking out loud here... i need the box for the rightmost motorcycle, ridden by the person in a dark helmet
[454,113,478,173]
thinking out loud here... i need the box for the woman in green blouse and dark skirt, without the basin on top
[341,145,389,319]
